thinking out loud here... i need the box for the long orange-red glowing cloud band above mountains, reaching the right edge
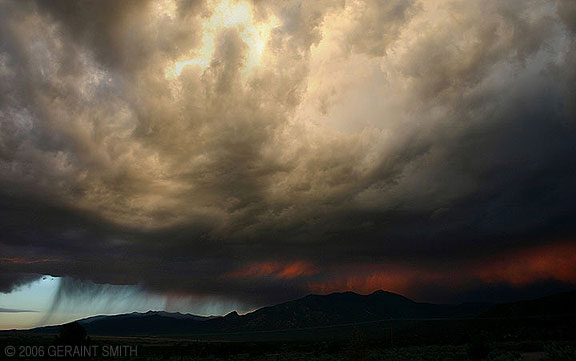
[309,243,576,294]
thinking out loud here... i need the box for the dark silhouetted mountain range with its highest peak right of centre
[31,291,490,336]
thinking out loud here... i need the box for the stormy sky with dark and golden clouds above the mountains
[0,0,576,328]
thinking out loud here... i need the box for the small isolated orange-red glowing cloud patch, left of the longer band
[224,261,318,279]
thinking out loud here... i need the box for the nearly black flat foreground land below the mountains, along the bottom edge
[0,330,576,361]
